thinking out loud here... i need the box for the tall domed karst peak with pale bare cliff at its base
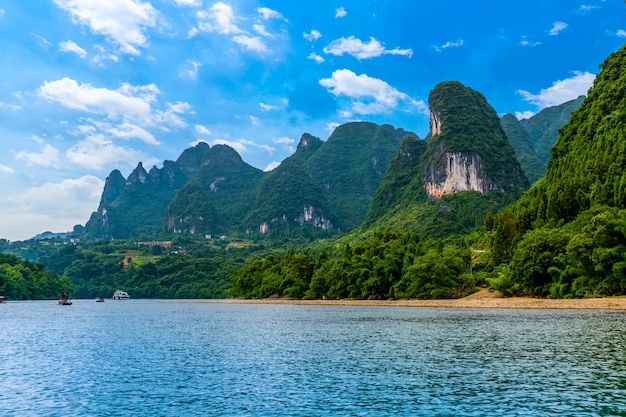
[422,81,528,199]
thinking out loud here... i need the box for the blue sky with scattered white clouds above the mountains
[0,0,626,241]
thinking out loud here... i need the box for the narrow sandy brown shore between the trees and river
[190,289,626,310]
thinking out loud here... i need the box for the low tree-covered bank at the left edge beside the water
[0,253,72,300]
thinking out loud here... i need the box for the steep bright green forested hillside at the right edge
[487,46,626,297]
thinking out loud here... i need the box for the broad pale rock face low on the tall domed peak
[424,152,502,199]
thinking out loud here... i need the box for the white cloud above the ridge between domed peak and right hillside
[517,71,595,110]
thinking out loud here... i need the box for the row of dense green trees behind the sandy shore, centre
[231,231,475,299]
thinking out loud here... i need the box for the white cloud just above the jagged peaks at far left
[65,134,158,170]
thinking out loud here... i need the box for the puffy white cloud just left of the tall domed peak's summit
[319,69,412,117]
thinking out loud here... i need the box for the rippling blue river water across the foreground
[0,300,626,416]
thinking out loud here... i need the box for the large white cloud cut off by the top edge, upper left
[53,0,157,55]
